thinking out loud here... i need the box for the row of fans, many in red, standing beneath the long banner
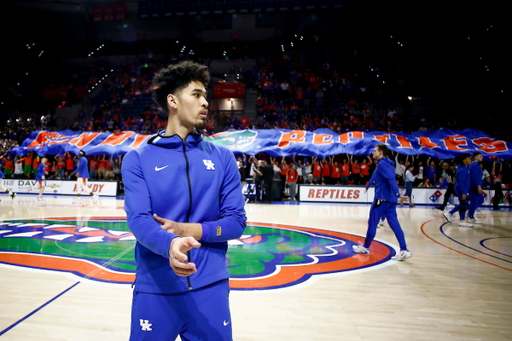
[0,121,512,205]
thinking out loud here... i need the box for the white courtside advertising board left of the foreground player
[2,179,117,197]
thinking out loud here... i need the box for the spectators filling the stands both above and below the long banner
[0,37,512,203]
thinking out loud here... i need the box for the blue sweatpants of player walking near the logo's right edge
[363,199,407,250]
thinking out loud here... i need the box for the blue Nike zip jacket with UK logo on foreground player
[122,133,247,293]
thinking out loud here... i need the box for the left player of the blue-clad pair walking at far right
[443,154,473,227]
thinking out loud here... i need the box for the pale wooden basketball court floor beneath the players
[0,194,512,341]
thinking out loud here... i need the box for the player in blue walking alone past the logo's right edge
[352,144,411,260]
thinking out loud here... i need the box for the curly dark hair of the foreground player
[151,60,210,112]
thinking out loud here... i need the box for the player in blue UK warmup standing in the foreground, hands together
[122,61,246,341]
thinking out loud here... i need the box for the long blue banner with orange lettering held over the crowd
[9,129,512,159]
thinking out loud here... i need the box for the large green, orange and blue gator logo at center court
[0,217,395,290]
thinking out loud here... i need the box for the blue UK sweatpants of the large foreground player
[130,279,233,341]
